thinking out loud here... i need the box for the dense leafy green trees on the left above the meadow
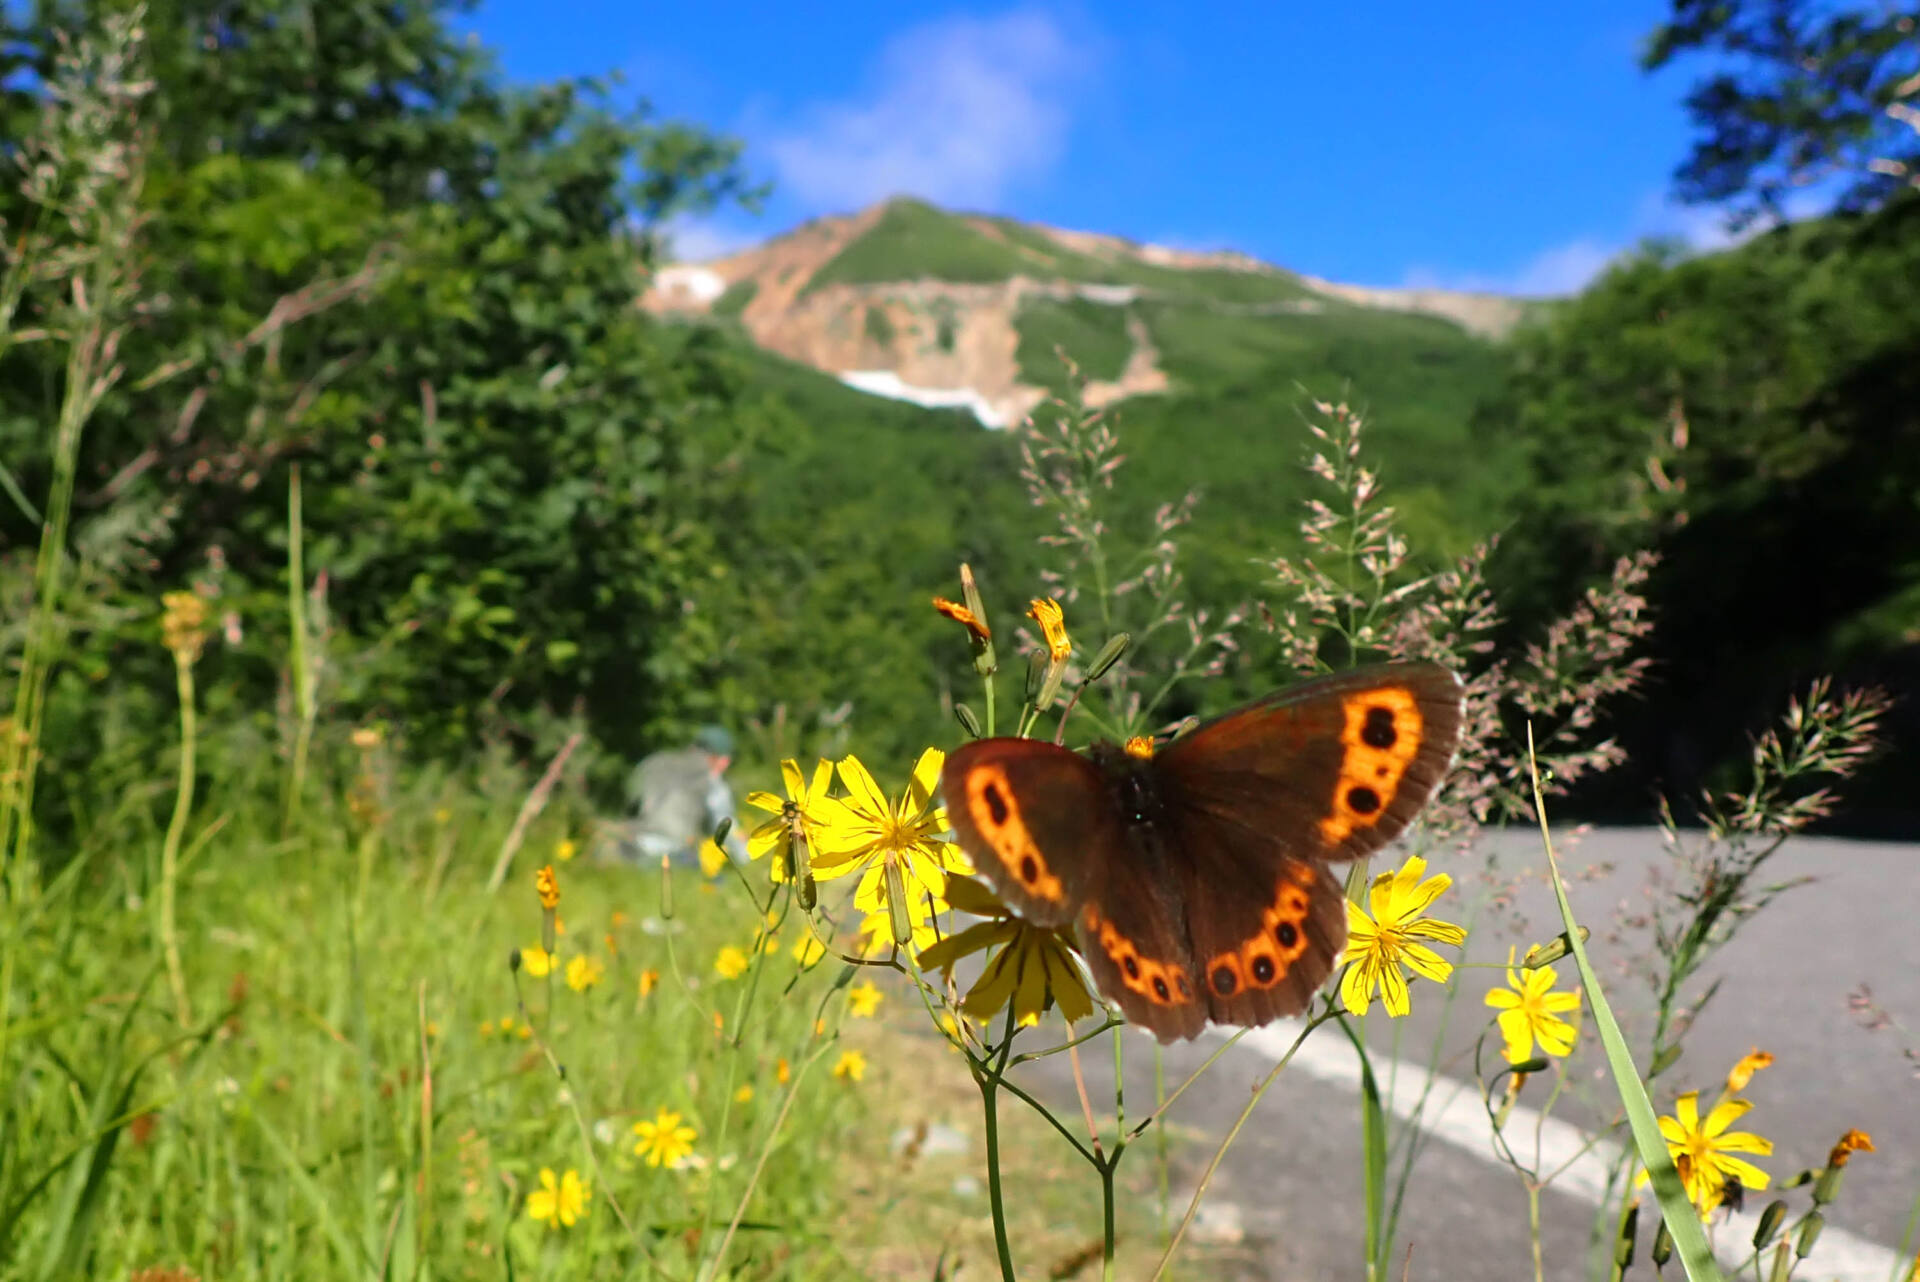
[0,0,756,806]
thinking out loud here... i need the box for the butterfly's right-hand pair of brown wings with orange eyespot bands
[1152,664,1461,1025]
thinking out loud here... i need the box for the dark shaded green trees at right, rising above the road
[1482,202,1920,814]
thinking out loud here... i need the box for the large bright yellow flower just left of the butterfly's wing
[814,748,970,940]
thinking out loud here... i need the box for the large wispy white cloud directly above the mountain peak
[766,12,1087,209]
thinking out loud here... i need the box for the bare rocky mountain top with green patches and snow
[641,200,1523,426]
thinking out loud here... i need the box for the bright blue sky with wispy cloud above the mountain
[460,0,1743,294]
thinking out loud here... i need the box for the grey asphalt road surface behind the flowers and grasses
[1006,829,1920,1282]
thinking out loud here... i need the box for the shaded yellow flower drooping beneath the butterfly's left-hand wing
[920,877,1092,1025]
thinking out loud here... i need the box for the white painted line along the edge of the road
[1208,1019,1903,1282]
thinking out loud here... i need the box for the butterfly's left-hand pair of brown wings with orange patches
[941,739,1206,1040]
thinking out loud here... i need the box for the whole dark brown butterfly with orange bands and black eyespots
[941,664,1461,1042]
